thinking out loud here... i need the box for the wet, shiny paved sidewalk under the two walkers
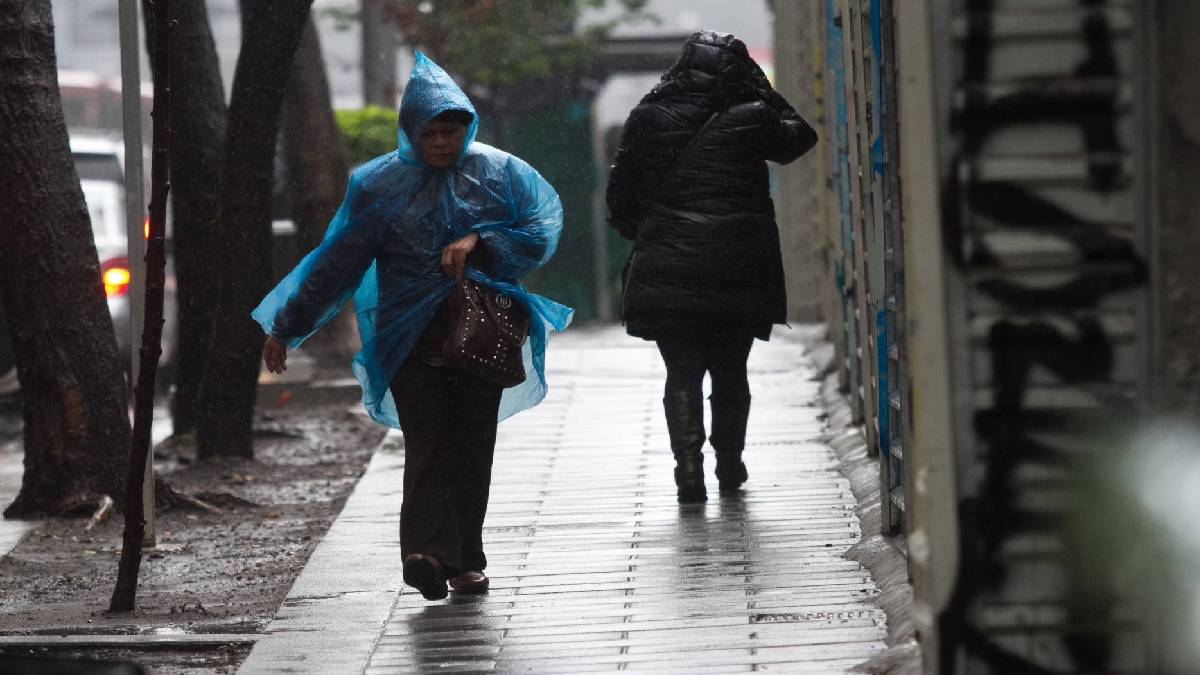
[241,328,886,674]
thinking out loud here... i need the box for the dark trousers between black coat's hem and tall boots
[655,334,754,400]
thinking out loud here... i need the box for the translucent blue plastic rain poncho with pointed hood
[252,53,574,426]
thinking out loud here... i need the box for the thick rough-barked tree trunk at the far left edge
[0,0,130,518]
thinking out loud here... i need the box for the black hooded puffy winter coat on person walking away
[607,31,817,340]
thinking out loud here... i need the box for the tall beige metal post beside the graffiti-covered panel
[895,0,960,673]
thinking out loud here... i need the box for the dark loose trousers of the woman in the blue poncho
[391,356,502,577]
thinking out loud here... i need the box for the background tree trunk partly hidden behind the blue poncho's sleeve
[283,18,358,365]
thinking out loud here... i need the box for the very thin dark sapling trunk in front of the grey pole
[108,0,171,611]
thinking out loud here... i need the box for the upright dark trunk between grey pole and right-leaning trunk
[159,0,226,434]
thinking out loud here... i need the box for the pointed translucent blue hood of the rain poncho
[396,52,479,165]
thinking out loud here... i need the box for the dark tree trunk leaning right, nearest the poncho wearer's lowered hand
[196,0,312,459]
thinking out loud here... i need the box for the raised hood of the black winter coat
[643,30,766,101]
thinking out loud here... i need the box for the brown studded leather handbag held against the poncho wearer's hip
[442,277,529,388]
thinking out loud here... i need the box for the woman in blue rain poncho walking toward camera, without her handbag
[253,53,571,599]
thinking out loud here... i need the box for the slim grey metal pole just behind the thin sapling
[119,0,157,548]
